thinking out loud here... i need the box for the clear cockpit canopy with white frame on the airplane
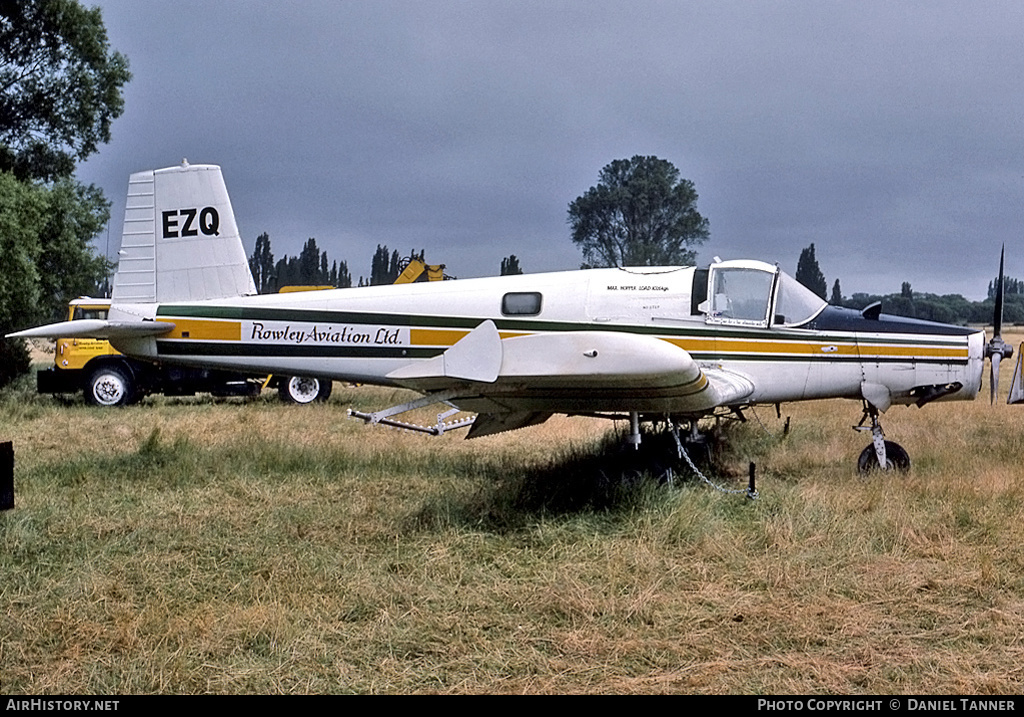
[701,261,827,327]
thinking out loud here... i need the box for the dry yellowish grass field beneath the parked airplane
[0,336,1024,694]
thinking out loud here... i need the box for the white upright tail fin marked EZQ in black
[112,162,256,303]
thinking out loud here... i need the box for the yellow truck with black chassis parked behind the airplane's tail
[36,297,332,406]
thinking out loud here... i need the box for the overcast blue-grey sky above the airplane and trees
[79,0,1024,298]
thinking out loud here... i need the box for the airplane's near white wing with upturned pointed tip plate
[387,321,754,419]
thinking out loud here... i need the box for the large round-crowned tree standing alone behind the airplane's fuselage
[568,156,709,266]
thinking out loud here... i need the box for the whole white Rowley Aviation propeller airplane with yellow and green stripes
[9,162,1021,470]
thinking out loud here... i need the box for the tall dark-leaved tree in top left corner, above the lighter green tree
[0,0,131,181]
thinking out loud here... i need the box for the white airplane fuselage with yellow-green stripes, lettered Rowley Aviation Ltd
[111,261,985,414]
